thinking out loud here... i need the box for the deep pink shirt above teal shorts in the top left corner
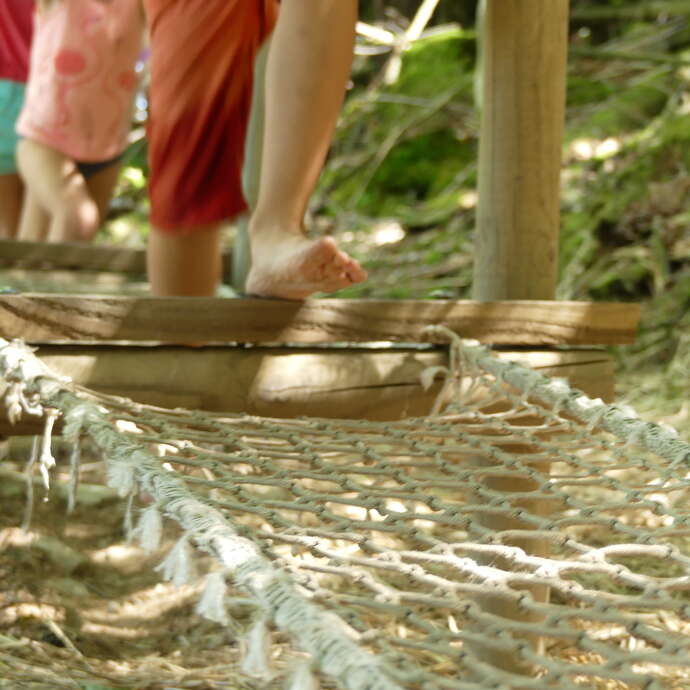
[0,0,34,82]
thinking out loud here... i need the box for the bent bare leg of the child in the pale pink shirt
[17,139,99,242]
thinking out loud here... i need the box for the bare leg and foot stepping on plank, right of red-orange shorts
[247,0,367,299]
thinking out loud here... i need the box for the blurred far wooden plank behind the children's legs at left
[0,239,231,275]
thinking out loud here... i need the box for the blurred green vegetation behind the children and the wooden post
[99,0,690,426]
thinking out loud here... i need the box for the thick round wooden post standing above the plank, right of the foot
[473,0,568,301]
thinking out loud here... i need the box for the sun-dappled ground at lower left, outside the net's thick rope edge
[0,438,292,690]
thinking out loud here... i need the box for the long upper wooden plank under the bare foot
[0,294,639,346]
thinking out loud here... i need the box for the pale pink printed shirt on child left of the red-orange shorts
[17,0,144,162]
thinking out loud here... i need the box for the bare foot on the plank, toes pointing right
[246,232,367,299]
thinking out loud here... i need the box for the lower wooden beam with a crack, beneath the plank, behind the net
[0,345,613,434]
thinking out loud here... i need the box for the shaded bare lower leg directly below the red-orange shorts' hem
[146,225,221,297]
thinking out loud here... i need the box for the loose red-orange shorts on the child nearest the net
[144,0,278,233]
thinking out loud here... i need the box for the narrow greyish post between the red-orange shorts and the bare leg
[232,38,270,294]
